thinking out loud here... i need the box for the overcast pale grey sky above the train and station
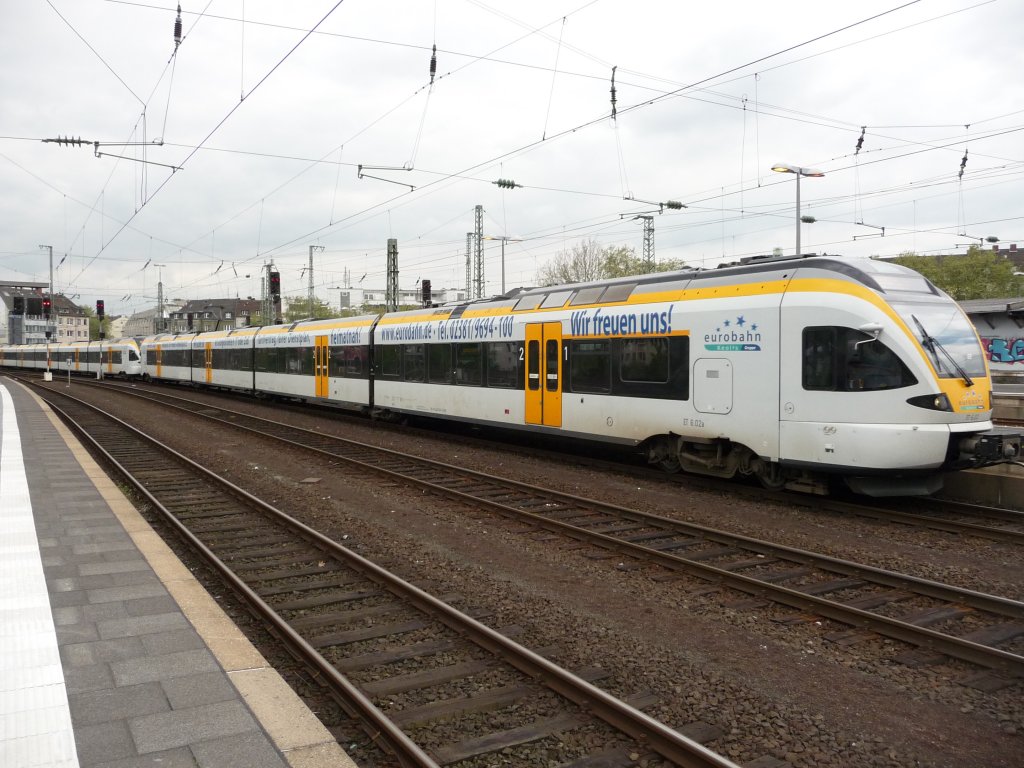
[0,0,1024,313]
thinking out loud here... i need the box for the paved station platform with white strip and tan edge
[0,377,355,768]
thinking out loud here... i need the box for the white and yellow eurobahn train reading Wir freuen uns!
[4,256,1021,496]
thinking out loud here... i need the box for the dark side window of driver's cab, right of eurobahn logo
[803,326,918,392]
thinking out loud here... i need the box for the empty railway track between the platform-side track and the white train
[37,376,1024,688]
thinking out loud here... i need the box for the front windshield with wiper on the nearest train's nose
[892,302,985,379]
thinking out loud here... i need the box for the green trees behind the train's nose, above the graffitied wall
[892,246,1024,301]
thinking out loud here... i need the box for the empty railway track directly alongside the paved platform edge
[24,376,736,768]
